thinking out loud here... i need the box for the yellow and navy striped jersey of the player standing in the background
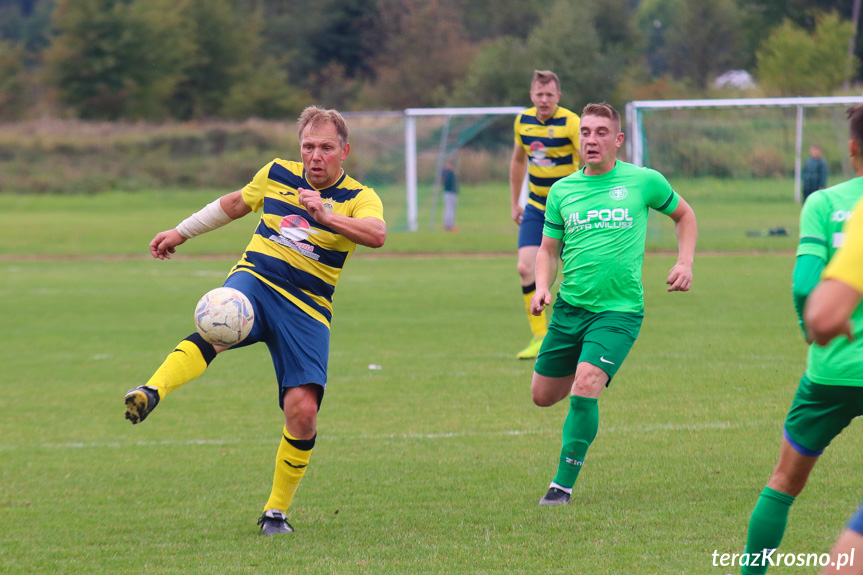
[514,106,581,211]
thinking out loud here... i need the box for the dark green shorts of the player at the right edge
[784,375,863,457]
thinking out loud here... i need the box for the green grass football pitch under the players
[0,181,863,575]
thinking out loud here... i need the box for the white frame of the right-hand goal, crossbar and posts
[626,96,863,203]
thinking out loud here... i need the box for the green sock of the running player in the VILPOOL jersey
[554,395,599,488]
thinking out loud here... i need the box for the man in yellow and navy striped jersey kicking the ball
[125,106,386,535]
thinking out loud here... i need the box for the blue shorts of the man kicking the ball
[225,271,330,409]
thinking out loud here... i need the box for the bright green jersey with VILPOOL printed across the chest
[542,160,680,313]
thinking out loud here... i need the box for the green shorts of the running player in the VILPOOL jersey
[534,297,644,385]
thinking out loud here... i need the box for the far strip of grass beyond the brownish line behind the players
[0,179,800,257]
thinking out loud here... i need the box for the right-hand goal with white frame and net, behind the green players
[625,96,863,250]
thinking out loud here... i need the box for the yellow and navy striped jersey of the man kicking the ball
[229,159,384,326]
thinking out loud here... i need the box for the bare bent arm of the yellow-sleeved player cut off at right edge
[803,278,861,345]
